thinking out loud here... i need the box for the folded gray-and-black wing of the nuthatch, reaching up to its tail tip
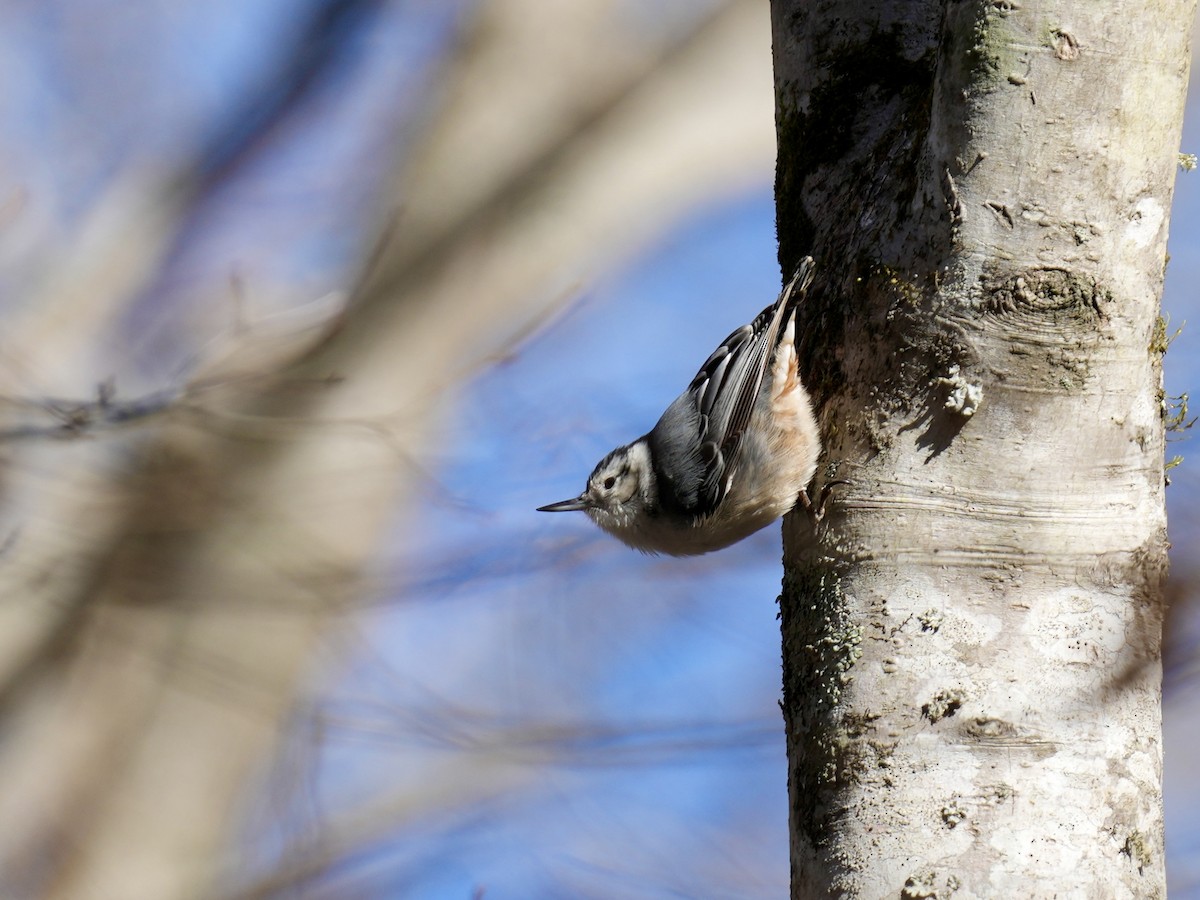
[649,257,812,516]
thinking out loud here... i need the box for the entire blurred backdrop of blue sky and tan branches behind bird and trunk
[0,0,1200,900]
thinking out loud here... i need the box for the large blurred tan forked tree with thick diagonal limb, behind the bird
[0,0,773,900]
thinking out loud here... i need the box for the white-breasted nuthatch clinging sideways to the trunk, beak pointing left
[539,257,828,556]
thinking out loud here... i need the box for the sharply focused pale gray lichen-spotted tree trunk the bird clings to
[772,0,1194,900]
